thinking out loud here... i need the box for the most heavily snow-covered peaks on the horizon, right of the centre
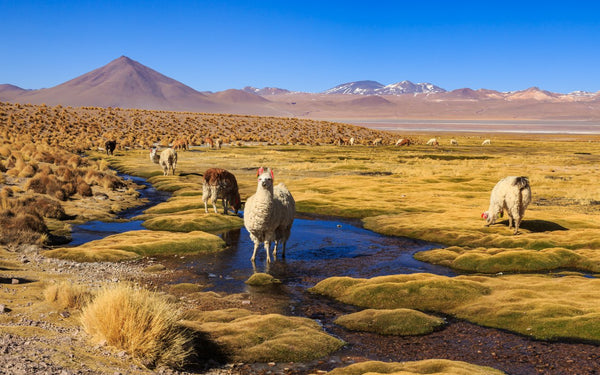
[323,81,446,95]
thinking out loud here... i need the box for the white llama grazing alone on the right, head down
[481,176,531,234]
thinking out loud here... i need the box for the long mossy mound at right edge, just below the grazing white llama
[415,246,600,273]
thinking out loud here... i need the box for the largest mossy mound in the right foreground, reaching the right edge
[310,274,600,342]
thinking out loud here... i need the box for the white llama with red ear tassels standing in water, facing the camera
[244,167,291,263]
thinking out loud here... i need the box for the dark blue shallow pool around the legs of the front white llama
[162,217,454,293]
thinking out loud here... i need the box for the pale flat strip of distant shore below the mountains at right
[335,119,600,135]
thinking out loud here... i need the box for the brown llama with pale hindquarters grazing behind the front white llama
[202,168,242,215]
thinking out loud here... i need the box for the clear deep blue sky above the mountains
[0,0,600,93]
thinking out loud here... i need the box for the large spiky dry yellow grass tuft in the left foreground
[81,285,192,368]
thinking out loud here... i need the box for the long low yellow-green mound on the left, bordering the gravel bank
[44,230,225,262]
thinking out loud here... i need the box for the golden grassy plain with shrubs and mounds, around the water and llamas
[0,103,600,374]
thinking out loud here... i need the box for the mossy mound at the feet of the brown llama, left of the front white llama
[141,207,244,232]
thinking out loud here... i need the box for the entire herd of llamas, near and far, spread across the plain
[138,138,531,263]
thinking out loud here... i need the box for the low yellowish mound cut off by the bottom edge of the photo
[328,359,505,375]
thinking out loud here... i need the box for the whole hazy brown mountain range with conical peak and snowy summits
[0,56,600,122]
